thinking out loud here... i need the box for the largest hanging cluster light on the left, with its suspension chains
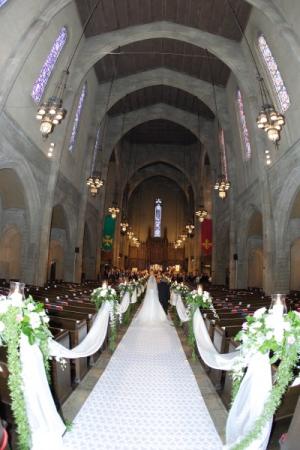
[36,0,101,138]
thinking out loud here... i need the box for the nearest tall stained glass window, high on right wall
[258,35,291,112]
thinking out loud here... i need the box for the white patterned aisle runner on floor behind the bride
[64,320,222,450]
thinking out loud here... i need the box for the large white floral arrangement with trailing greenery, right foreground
[232,308,300,450]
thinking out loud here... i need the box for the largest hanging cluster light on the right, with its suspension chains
[227,0,285,145]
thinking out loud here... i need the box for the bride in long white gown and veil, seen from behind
[137,275,167,323]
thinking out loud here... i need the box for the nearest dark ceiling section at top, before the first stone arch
[76,0,251,41]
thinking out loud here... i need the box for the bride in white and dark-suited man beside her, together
[137,275,170,323]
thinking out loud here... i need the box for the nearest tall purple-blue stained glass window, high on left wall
[31,26,68,103]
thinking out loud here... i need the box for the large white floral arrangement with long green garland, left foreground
[0,294,52,450]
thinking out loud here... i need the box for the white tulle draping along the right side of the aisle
[176,294,272,450]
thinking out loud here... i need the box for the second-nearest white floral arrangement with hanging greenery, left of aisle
[91,283,119,351]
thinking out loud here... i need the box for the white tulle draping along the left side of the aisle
[20,293,135,450]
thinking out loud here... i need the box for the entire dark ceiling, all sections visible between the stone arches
[76,0,251,151]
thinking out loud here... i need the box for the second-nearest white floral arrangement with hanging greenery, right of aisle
[185,286,219,359]
